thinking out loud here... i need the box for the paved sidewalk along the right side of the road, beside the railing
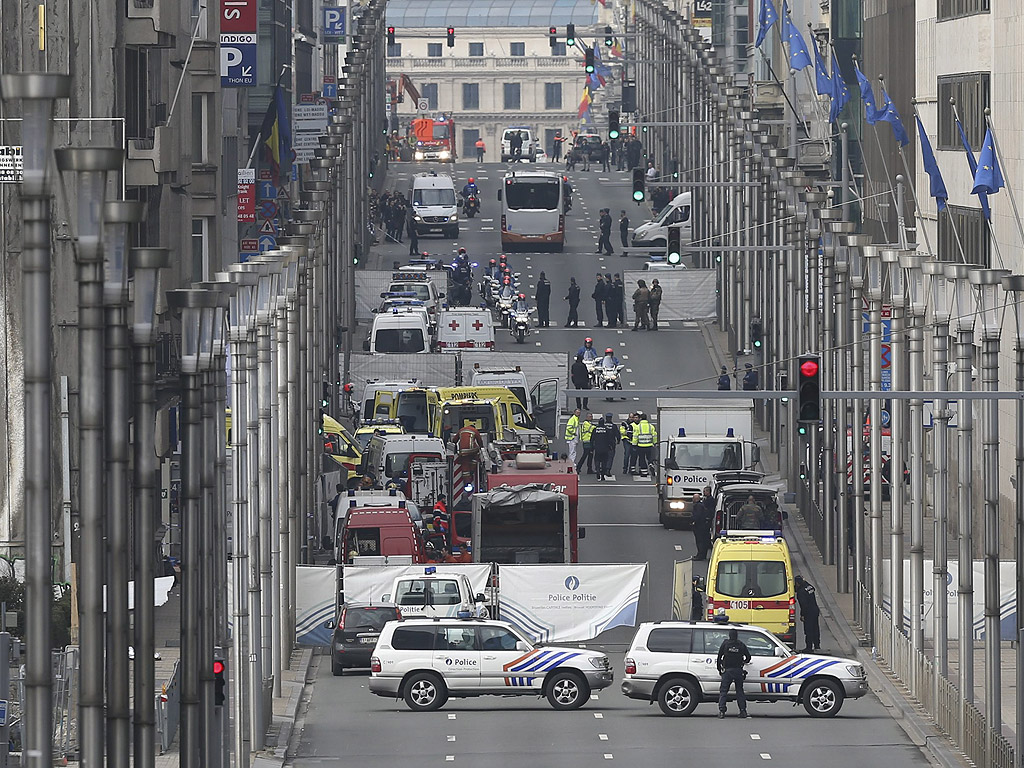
[701,324,970,768]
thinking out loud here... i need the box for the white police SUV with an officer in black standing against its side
[622,622,868,718]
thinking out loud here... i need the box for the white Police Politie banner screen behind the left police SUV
[499,563,647,642]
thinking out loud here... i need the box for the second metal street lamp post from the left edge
[55,146,128,765]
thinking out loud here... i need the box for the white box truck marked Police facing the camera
[657,398,761,527]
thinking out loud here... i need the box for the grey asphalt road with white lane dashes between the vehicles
[294,159,929,768]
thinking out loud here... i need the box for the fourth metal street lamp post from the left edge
[129,248,171,768]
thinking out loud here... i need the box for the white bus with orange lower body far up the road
[498,170,565,251]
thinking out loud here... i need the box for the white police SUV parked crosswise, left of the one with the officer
[369,618,613,712]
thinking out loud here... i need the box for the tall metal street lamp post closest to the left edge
[0,73,71,768]
